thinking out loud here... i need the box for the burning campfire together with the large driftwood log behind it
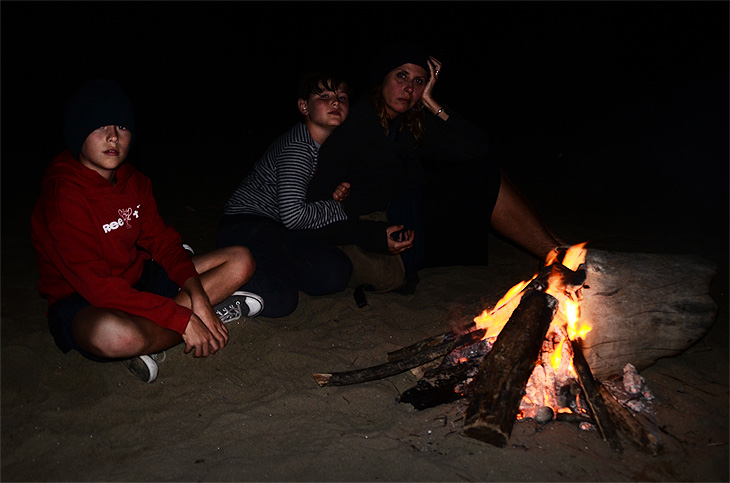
[314,244,716,454]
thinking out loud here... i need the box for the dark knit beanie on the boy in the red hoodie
[63,79,134,158]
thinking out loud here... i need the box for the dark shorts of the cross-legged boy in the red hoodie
[48,260,180,362]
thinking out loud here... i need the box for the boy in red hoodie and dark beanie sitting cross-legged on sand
[31,80,263,382]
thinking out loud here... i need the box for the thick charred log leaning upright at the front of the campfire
[464,290,558,447]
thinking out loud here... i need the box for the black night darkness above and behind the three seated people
[1,1,728,258]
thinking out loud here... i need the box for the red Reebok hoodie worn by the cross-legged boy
[31,151,198,334]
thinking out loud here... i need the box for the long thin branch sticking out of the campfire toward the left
[314,329,486,387]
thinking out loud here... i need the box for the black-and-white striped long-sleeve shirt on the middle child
[224,123,347,230]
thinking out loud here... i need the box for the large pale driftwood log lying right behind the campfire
[581,249,717,380]
